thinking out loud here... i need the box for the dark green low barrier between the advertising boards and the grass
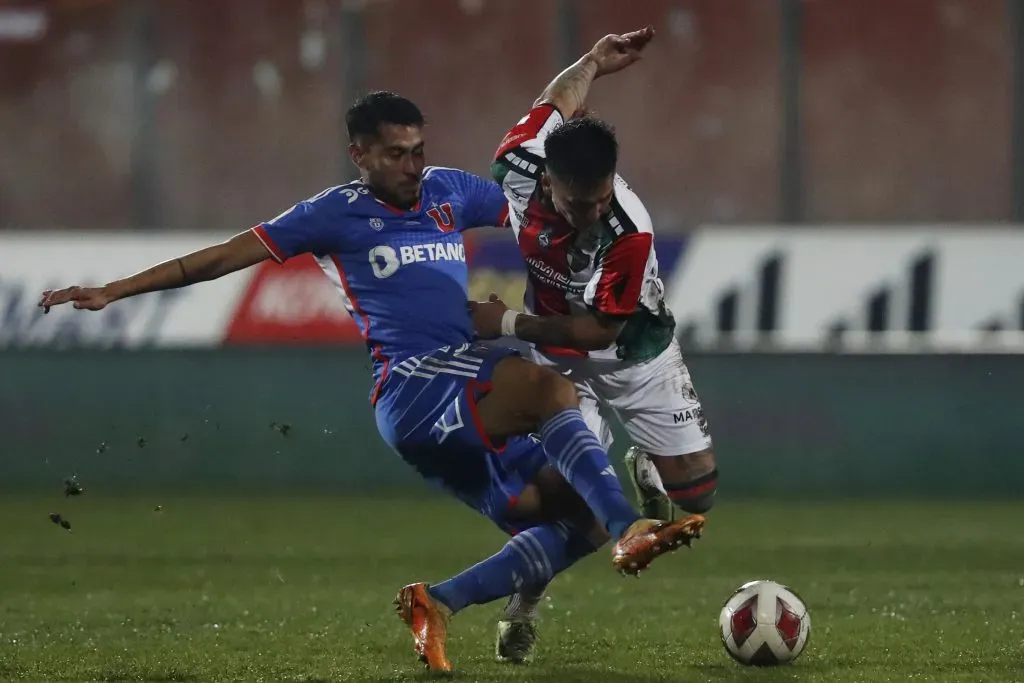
[0,347,1024,499]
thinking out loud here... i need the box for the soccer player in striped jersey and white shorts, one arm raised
[474,27,718,661]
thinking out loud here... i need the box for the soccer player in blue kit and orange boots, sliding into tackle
[39,57,703,671]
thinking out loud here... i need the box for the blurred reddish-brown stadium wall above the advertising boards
[0,0,1016,229]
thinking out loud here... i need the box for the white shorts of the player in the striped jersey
[531,339,712,456]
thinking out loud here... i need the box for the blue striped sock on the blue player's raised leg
[541,408,640,539]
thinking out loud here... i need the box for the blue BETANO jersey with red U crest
[253,166,508,402]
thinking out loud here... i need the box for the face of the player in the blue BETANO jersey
[349,123,426,209]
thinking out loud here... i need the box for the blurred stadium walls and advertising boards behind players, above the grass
[0,0,1024,496]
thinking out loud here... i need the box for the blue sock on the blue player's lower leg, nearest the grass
[427,522,596,612]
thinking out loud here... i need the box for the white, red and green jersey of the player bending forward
[492,104,675,360]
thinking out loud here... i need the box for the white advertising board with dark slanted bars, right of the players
[668,225,1024,350]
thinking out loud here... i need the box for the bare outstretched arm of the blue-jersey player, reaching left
[39,230,270,313]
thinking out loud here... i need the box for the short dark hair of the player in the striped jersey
[544,117,618,185]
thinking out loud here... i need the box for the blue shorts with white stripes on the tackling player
[376,344,547,533]
